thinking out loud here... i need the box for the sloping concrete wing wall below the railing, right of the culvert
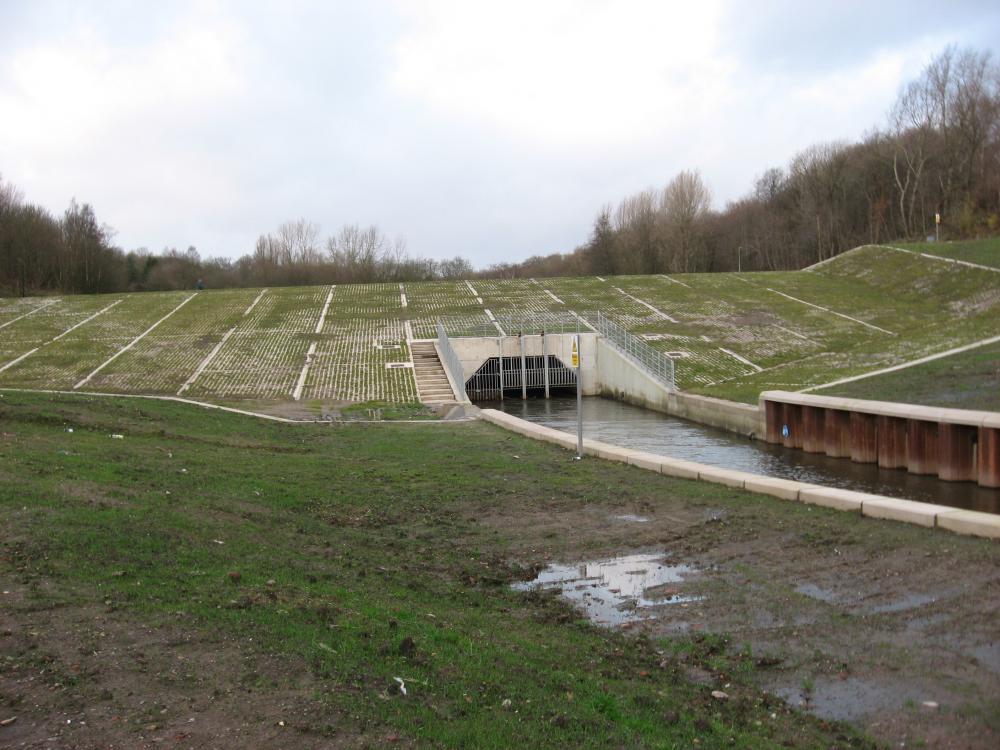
[597,339,763,437]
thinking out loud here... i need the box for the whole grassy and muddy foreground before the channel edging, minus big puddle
[7,394,1000,748]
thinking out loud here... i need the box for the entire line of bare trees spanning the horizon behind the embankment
[0,47,1000,295]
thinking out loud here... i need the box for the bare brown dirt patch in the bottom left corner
[0,581,398,748]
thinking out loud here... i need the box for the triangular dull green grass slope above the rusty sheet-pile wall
[817,344,1000,411]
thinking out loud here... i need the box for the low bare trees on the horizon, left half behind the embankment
[0,189,473,296]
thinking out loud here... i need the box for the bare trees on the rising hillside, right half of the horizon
[487,47,1000,277]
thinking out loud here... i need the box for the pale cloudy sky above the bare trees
[0,0,1000,267]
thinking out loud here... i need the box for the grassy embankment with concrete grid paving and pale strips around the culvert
[0,243,1000,403]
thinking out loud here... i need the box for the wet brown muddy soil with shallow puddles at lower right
[483,491,1000,749]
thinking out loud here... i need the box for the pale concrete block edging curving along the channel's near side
[480,409,1000,539]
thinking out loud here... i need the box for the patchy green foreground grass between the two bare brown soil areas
[0,392,868,748]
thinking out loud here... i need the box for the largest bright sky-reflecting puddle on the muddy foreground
[513,554,700,627]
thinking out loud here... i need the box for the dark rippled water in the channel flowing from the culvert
[486,397,1000,513]
